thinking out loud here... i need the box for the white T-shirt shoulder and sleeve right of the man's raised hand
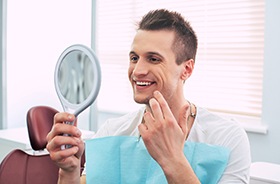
[190,108,251,183]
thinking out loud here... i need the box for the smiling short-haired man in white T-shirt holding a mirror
[47,9,251,184]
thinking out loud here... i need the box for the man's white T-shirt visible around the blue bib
[86,107,251,184]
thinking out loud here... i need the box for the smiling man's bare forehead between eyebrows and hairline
[131,30,175,56]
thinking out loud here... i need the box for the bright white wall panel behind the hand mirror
[7,0,92,128]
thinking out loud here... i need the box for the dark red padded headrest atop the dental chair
[26,106,58,150]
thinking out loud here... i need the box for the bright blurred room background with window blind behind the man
[0,0,280,164]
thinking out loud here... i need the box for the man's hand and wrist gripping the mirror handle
[47,113,84,184]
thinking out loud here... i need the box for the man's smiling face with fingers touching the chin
[128,30,182,104]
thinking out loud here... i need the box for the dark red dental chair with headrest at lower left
[0,106,85,184]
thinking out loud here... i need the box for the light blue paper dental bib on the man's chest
[86,136,229,184]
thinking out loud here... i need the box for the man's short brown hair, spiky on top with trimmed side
[138,9,197,65]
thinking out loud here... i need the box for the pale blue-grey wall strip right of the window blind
[248,0,280,164]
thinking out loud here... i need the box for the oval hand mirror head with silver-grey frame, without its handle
[54,45,101,117]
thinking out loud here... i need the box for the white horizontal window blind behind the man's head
[96,0,264,117]
